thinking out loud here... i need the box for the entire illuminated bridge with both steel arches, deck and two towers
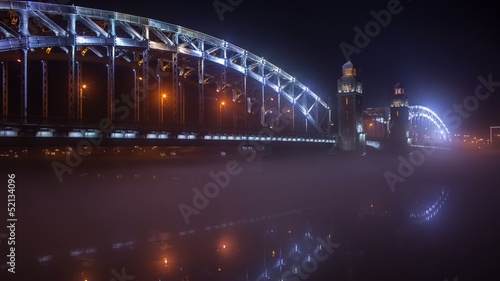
[0,1,450,152]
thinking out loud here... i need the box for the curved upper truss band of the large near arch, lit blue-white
[0,1,330,133]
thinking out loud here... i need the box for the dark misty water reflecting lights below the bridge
[0,144,500,281]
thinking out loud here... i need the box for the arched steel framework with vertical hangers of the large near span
[0,1,330,133]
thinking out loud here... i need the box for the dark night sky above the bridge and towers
[69,0,500,136]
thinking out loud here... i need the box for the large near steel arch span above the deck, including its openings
[0,1,331,134]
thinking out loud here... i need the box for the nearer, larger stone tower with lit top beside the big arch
[337,61,365,153]
